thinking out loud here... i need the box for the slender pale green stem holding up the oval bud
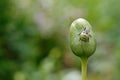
[81,58,88,80]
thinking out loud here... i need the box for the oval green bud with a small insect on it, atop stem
[70,18,96,57]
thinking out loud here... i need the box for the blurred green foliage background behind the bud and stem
[0,0,120,80]
